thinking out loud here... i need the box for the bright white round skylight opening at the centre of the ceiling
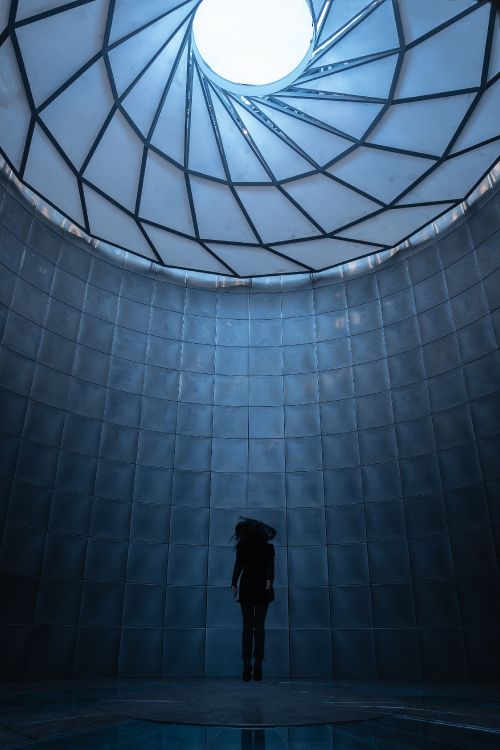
[193,0,313,86]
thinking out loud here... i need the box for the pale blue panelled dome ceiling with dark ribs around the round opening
[0,0,500,276]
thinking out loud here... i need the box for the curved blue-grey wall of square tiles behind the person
[0,175,500,680]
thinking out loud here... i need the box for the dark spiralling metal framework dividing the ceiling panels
[0,0,500,276]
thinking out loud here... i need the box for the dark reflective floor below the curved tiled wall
[0,678,500,750]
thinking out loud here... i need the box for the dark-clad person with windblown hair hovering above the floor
[231,516,276,681]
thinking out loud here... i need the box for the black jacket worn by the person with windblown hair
[231,542,274,603]
